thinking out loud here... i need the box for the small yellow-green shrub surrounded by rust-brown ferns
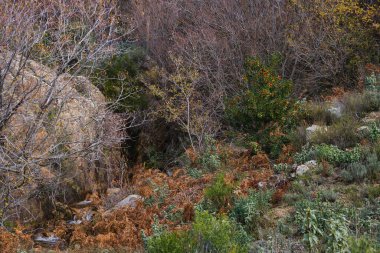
[204,173,234,210]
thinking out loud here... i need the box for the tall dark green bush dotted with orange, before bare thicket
[226,55,294,132]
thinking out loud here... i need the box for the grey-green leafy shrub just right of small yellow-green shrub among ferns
[230,191,272,235]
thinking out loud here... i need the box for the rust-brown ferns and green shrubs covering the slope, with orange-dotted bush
[2,56,380,252]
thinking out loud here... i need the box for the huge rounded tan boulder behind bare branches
[0,52,111,221]
